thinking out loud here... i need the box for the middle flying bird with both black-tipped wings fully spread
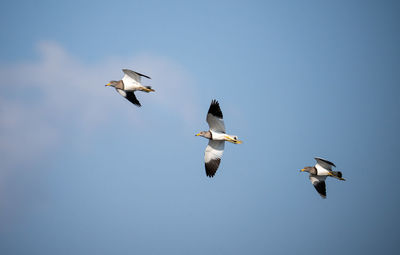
[196,100,242,177]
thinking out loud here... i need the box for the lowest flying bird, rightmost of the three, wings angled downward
[300,158,345,198]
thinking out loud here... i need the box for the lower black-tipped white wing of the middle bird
[204,140,225,177]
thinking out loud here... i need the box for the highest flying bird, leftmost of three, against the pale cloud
[106,69,155,107]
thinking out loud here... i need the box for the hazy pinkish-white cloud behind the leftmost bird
[0,42,197,171]
